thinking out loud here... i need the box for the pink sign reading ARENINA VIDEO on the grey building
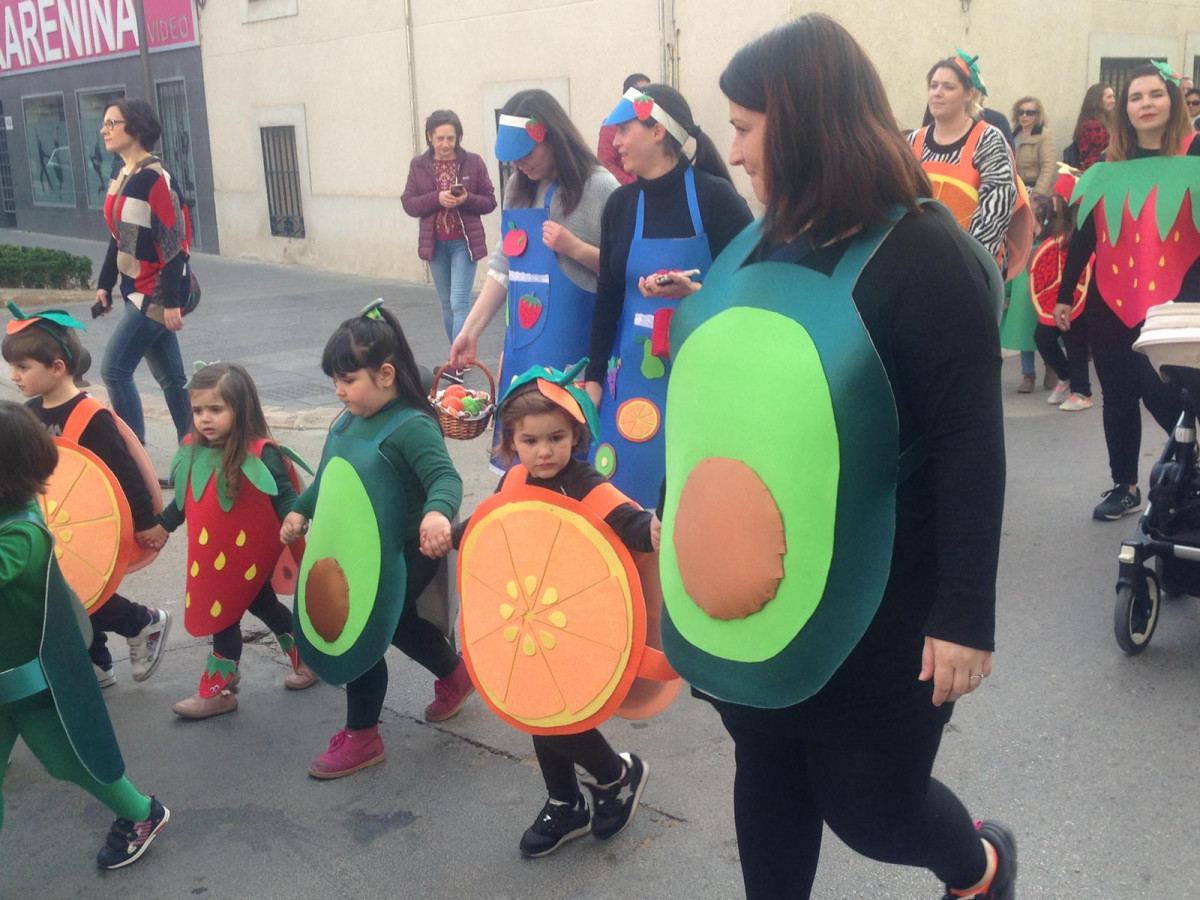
[0,0,198,76]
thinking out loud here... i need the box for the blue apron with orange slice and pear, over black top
[592,168,713,509]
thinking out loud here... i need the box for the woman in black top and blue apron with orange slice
[586,84,752,508]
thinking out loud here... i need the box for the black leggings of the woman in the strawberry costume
[1084,294,1183,485]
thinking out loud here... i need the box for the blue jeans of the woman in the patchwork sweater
[100,300,192,444]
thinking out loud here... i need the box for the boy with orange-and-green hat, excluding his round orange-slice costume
[0,302,170,688]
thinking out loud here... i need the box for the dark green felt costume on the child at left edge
[0,511,125,785]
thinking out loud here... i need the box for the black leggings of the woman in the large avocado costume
[719,704,988,900]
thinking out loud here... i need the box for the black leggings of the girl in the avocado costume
[346,540,458,731]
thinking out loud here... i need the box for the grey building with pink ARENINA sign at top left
[0,0,220,252]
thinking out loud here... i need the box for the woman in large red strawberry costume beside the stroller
[1055,62,1200,521]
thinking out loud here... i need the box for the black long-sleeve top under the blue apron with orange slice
[586,157,754,382]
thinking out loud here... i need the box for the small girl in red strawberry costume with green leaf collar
[144,362,317,719]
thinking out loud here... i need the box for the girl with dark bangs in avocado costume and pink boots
[281,300,474,779]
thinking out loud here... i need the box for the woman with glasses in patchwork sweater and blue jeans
[96,97,192,443]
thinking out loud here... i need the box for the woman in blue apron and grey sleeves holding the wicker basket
[450,90,617,472]
